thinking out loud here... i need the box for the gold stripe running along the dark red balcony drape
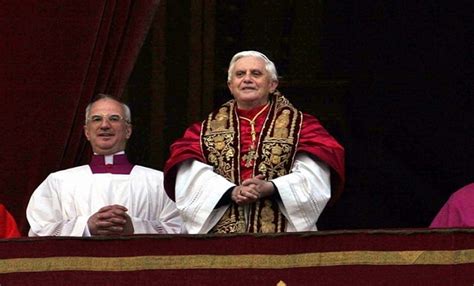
[0,249,474,274]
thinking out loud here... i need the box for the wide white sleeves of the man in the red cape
[175,153,331,234]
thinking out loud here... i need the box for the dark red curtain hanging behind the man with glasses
[0,0,158,234]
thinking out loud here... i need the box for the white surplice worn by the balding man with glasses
[26,165,181,236]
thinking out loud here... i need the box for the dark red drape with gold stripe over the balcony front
[0,229,474,286]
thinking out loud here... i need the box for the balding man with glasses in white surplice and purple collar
[26,95,181,236]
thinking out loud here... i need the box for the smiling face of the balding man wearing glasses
[84,98,132,155]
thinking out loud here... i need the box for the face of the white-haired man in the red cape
[227,56,278,109]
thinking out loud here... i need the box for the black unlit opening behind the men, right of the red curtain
[127,1,474,229]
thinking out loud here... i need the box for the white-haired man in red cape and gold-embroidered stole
[165,51,344,233]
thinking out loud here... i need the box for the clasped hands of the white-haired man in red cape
[232,175,275,205]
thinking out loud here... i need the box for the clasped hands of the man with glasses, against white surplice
[87,205,134,236]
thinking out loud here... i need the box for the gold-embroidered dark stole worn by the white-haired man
[201,93,303,233]
